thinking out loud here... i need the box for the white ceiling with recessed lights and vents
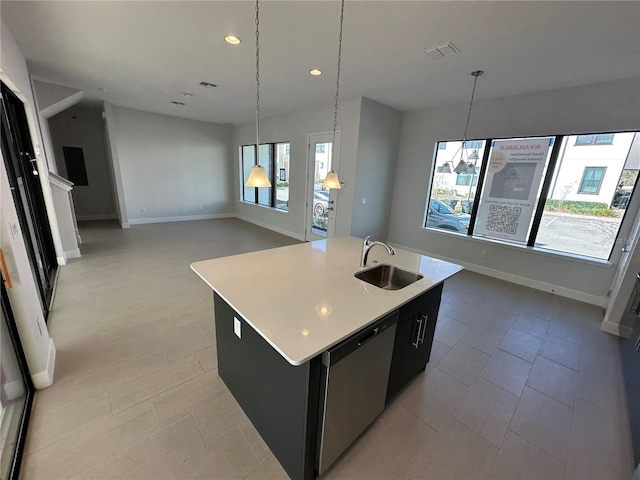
[0,0,640,127]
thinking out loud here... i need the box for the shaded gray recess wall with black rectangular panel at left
[49,105,116,220]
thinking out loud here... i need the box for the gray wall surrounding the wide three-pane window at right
[389,78,640,300]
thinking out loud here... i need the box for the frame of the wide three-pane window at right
[428,130,640,263]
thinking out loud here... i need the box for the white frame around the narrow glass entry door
[304,130,341,242]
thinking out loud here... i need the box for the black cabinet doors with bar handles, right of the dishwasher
[387,283,443,403]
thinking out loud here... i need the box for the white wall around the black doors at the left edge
[0,20,56,388]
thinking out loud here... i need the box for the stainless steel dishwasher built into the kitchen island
[316,310,398,475]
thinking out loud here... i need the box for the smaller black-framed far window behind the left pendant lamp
[240,142,290,212]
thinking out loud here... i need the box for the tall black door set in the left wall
[0,83,58,319]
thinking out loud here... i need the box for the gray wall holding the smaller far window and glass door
[233,97,361,239]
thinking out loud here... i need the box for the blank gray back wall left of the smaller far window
[109,106,233,224]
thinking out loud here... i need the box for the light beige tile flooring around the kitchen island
[22,219,632,480]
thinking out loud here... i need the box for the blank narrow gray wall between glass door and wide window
[351,98,402,240]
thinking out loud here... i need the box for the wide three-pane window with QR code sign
[424,132,640,260]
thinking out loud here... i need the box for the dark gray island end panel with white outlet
[214,293,321,480]
